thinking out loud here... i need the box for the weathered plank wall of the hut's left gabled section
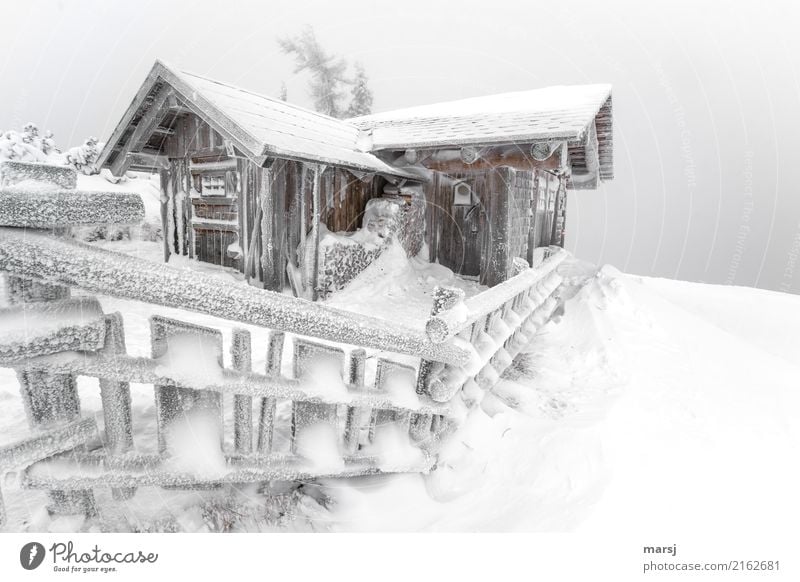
[162,114,384,291]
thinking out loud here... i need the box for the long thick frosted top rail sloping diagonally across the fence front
[0,228,470,364]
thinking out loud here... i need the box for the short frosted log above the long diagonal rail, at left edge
[0,188,144,228]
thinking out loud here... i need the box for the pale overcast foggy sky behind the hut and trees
[0,0,800,293]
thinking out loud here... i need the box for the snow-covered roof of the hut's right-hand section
[349,85,611,151]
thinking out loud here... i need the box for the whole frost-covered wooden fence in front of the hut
[0,162,564,522]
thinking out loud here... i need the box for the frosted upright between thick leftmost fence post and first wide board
[100,313,136,501]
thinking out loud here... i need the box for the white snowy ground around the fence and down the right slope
[0,248,800,532]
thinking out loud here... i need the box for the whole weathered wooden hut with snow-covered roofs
[98,62,612,297]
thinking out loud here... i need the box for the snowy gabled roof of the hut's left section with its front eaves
[99,61,416,176]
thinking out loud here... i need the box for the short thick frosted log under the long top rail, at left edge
[0,297,105,362]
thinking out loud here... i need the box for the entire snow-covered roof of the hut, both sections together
[97,61,613,187]
